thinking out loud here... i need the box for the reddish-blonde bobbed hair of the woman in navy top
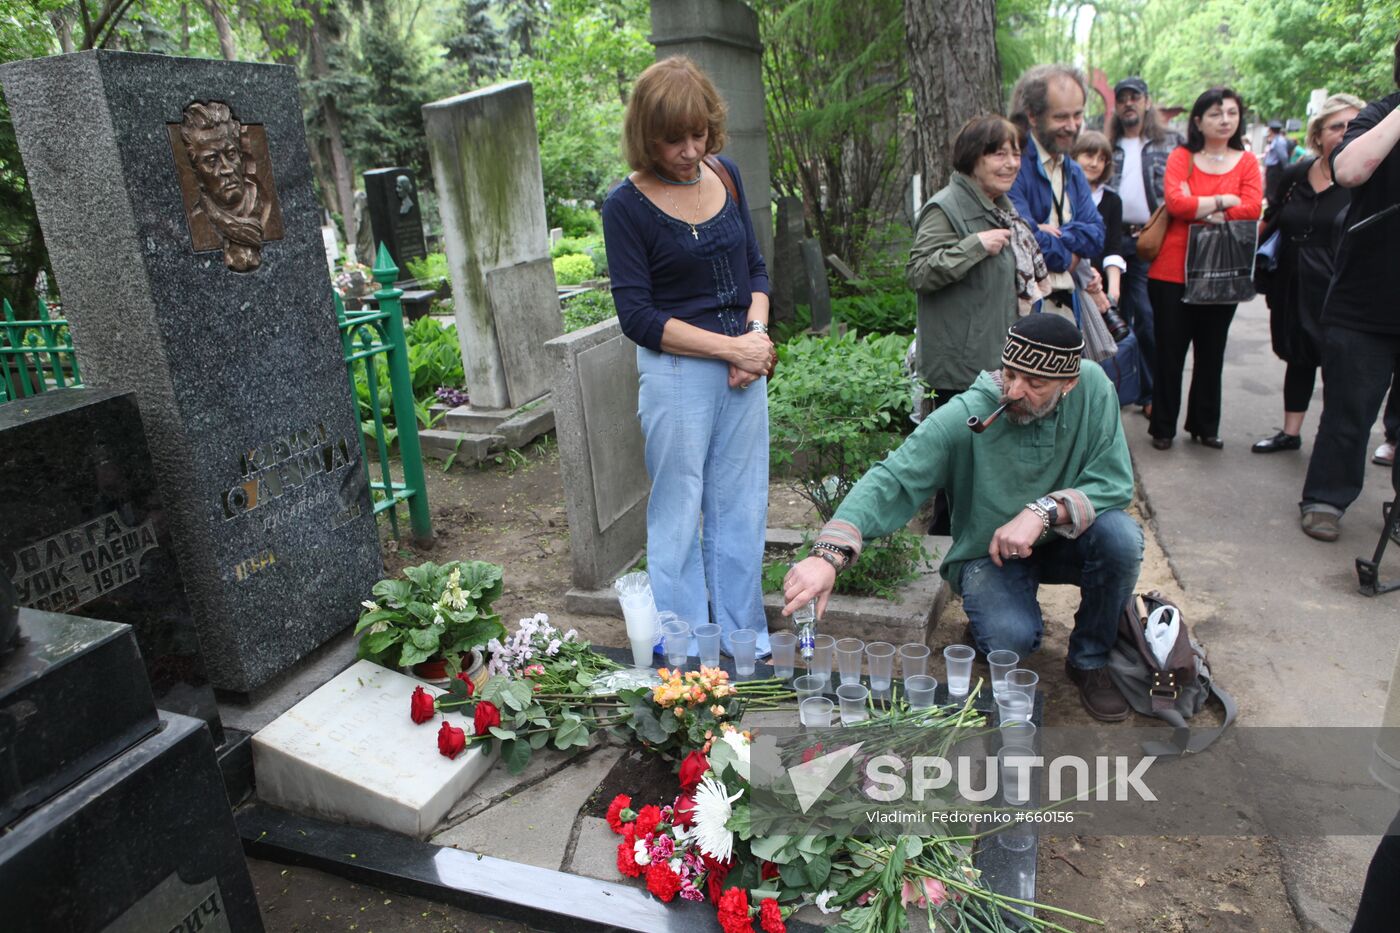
[623,55,728,172]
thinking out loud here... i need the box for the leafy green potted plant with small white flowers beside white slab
[356,560,505,685]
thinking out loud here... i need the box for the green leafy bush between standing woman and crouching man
[769,332,913,521]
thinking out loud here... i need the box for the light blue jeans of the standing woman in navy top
[637,347,769,657]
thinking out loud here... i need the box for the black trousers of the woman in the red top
[1147,279,1235,437]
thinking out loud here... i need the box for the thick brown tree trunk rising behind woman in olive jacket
[904,0,1002,196]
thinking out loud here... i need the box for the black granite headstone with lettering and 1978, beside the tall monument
[0,389,223,744]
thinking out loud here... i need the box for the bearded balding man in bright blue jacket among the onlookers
[1008,64,1103,316]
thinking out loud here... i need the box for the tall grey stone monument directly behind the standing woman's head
[651,0,773,263]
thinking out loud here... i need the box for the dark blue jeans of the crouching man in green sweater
[958,509,1142,671]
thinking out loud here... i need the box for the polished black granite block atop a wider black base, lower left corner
[0,609,158,823]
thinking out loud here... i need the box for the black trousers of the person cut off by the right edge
[1299,326,1400,511]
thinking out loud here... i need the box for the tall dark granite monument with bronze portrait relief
[0,50,382,692]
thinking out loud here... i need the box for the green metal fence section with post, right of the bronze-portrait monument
[336,244,433,544]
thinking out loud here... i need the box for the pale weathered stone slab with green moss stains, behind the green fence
[423,81,564,409]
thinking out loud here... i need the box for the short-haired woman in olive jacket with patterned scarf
[904,115,1046,403]
